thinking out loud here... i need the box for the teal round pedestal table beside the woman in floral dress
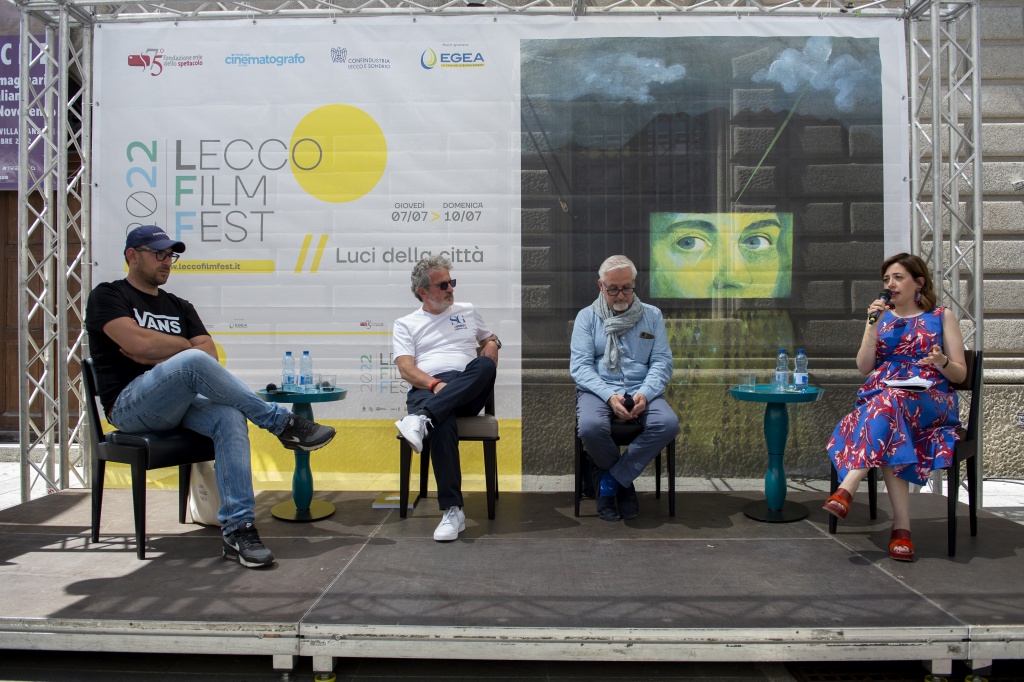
[729,384,824,523]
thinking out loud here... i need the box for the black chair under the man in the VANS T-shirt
[82,359,214,559]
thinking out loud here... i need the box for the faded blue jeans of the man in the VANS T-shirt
[110,348,291,536]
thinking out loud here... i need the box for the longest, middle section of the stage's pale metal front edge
[299,624,969,674]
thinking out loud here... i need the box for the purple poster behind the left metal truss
[0,36,45,189]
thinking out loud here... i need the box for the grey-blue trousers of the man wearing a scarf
[577,389,679,486]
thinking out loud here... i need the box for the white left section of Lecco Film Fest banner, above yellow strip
[93,19,520,419]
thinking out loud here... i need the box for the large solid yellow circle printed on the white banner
[289,104,387,204]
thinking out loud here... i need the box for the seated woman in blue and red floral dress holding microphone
[824,253,967,561]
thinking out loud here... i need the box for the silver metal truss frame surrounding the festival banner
[15,0,982,501]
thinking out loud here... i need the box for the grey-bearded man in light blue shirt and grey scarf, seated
[569,256,679,521]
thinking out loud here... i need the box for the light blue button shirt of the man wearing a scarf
[569,303,672,402]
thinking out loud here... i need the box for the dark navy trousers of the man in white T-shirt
[406,355,498,509]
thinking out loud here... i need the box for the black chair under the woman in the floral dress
[828,350,983,556]
